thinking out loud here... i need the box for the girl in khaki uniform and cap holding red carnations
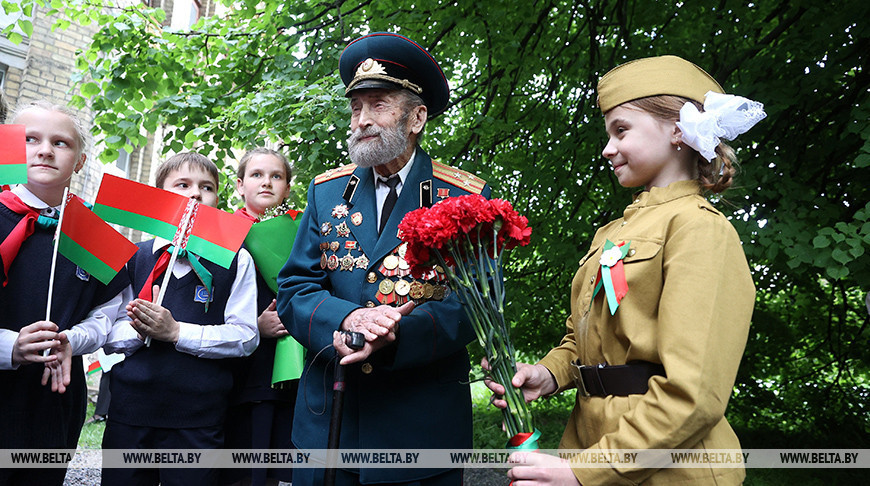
[489,56,765,486]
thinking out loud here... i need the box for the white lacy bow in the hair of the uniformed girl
[677,91,767,162]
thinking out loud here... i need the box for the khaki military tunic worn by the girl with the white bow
[541,181,755,485]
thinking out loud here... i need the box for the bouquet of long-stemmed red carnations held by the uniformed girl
[399,195,539,448]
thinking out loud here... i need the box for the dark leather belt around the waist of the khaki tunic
[571,361,667,397]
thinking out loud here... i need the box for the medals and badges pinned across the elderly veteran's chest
[320,240,450,305]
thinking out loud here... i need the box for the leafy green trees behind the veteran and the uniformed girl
[5,0,870,447]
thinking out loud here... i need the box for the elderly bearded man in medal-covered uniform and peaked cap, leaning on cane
[278,33,490,486]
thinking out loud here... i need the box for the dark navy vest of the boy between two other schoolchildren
[109,240,244,428]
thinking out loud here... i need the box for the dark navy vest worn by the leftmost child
[0,204,128,449]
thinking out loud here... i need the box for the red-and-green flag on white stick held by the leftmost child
[57,196,137,284]
